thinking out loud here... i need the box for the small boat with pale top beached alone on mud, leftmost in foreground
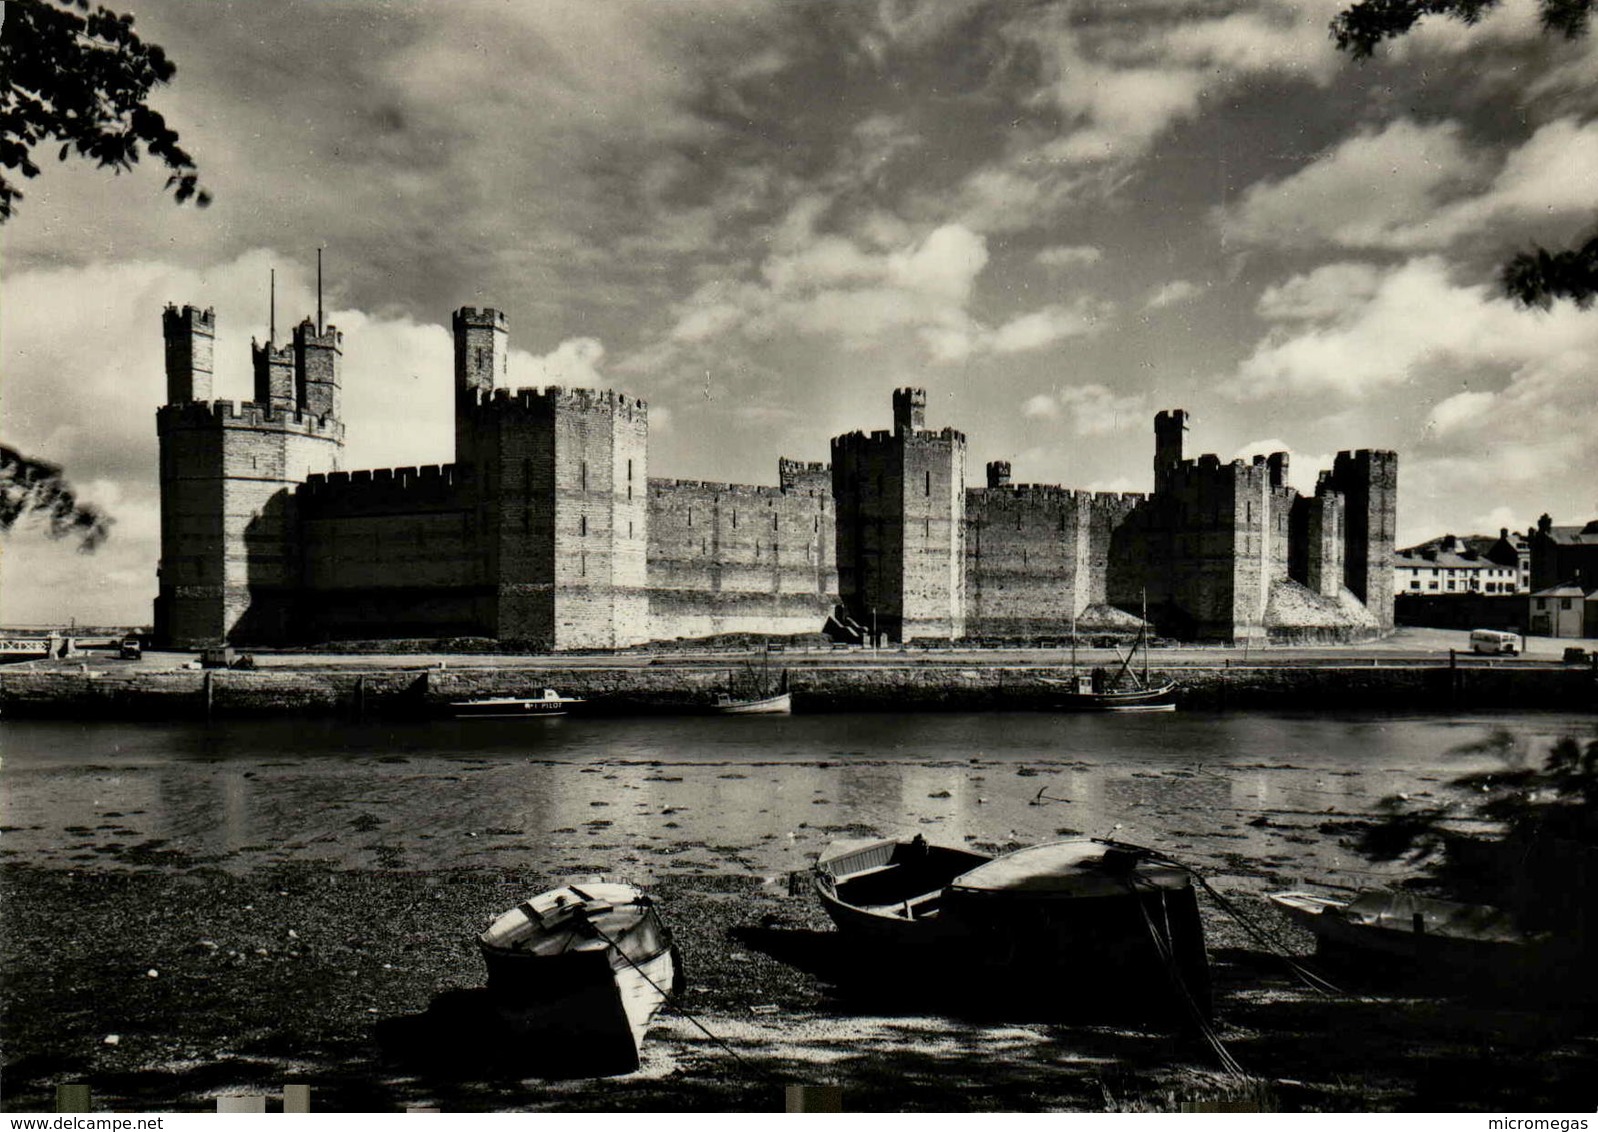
[478,881,682,1074]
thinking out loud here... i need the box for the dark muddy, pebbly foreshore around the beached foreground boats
[0,863,1590,1111]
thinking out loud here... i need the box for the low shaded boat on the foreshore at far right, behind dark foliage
[1267,892,1548,974]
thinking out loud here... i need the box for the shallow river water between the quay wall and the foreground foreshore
[0,713,1593,884]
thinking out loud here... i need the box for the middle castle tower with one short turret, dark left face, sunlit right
[833,389,965,641]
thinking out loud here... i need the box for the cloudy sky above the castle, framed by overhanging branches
[0,0,1598,625]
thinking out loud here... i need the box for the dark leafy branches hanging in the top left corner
[0,0,211,222]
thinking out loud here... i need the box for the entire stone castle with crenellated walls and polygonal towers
[155,305,1397,651]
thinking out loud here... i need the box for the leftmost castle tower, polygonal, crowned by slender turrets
[155,307,344,648]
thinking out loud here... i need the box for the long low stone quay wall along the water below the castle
[0,662,1598,719]
